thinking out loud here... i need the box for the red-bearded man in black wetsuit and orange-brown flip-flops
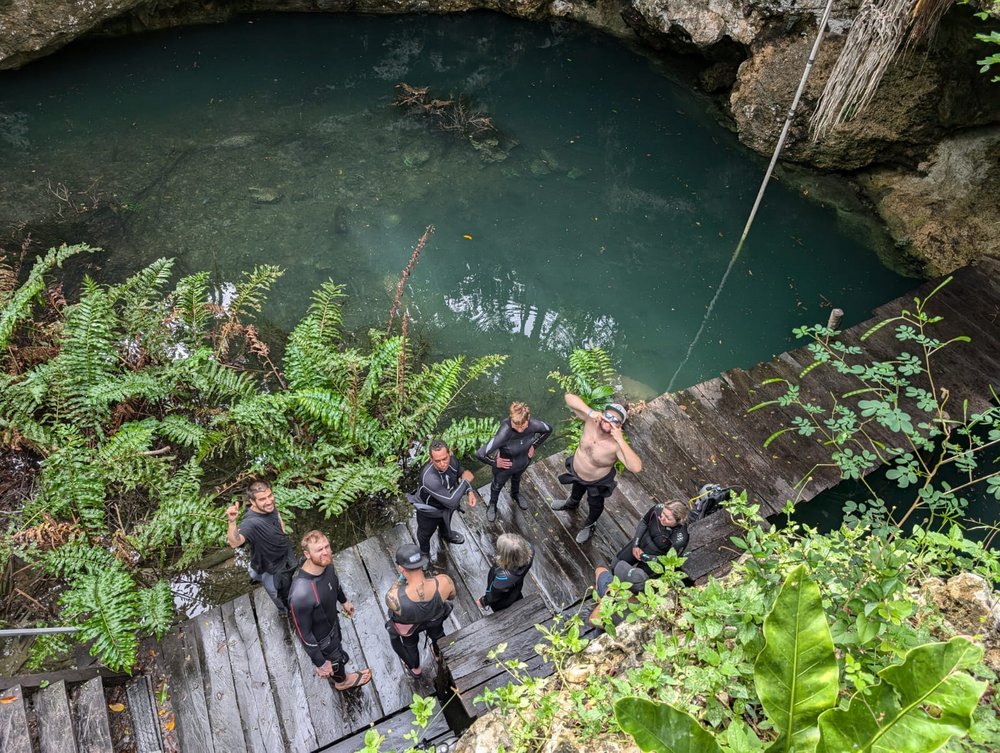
[288,531,372,690]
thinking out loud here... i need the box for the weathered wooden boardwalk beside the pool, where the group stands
[11,260,1000,753]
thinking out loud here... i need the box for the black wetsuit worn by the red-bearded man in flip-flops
[288,565,347,667]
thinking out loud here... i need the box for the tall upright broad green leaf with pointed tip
[754,565,839,753]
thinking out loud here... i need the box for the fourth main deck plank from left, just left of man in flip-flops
[250,588,319,753]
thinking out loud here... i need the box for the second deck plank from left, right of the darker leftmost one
[194,608,247,753]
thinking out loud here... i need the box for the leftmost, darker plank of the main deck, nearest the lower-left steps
[160,624,216,753]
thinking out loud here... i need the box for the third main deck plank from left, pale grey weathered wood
[222,594,285,753]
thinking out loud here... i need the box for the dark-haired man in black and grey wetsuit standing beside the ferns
[406,439,476,559]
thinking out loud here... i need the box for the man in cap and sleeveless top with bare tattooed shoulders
[385,544,455,677]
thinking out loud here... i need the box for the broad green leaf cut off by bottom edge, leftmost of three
[615,696,722,753]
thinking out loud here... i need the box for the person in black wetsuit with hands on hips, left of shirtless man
[476,402,552,522]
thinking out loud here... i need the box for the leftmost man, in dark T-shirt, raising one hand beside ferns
[226,481,299,614]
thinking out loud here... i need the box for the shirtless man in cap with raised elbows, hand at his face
[550,392,642,544]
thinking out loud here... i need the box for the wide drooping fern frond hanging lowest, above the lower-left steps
[59,567,139,671]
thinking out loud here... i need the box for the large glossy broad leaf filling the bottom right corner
[817,636,986,753]
